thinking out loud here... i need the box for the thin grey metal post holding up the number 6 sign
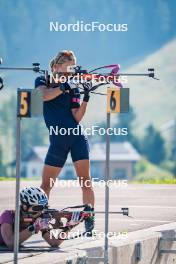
[104,113,110,264]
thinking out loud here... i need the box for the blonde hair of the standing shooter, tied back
[50,50,76,70]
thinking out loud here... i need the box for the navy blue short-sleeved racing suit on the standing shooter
[35,76,89,167]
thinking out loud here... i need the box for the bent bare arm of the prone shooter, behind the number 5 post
[1,223,32,248]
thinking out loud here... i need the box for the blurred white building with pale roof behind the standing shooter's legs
[22,142,140,179]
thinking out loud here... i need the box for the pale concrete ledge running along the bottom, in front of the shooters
[2,222,176,264]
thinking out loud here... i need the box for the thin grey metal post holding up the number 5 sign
[14,90,21,264]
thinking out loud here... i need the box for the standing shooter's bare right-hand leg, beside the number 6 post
[74,159,95,207]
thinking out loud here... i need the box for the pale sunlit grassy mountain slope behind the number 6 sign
[85,40,176,131]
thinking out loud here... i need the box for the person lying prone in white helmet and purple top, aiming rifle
[0,187,63,249]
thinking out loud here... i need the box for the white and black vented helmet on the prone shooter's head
[20,187,48,207]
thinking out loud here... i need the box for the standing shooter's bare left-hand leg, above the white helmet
[41,164,62,197]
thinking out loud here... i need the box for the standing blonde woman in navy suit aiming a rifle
[35,51,94,234]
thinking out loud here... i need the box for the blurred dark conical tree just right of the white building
[142,125,166,164]
